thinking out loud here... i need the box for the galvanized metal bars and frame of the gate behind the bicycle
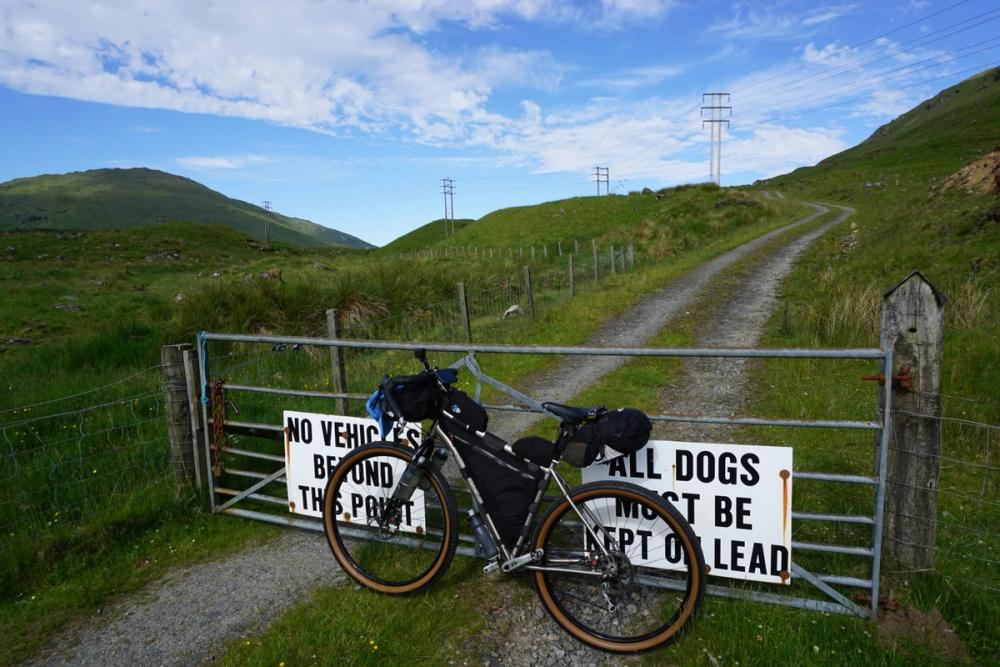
[198,332,892,618]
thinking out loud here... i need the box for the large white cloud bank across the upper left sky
[0,0,580,141]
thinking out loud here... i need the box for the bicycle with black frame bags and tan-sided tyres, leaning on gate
[323,350,706,653]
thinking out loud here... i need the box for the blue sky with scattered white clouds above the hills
[0,0,1000,244]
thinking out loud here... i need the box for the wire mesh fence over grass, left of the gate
[0,366,173,576]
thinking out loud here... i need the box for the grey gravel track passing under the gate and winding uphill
[30,204,849,665]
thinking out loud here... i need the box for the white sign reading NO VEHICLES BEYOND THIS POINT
[282,410,425,533]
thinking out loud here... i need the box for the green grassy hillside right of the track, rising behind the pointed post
[753,65,1000,664]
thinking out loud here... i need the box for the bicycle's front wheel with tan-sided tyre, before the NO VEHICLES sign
[323,442,458,595]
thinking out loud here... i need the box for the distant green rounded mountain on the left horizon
[0,168,373,248]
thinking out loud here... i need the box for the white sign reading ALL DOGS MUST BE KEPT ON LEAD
[583,440,792,584]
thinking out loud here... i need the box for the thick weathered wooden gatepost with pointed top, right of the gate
[881,271,947,570]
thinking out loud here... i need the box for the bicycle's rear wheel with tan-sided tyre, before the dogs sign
[534,482,705,653]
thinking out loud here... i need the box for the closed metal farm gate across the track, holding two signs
[191,332,893,618]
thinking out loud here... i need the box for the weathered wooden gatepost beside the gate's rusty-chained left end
[160,343,197,492]
